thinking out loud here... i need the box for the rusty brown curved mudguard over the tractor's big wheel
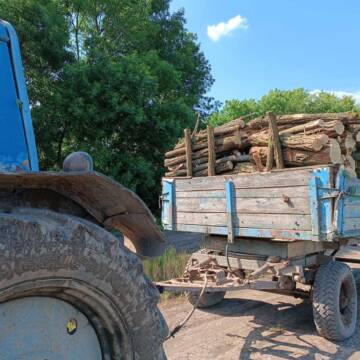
[0,171,165,256]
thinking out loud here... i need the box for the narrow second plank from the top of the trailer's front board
[176,186,308,199]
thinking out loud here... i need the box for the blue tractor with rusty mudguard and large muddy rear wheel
[0,20,167,360]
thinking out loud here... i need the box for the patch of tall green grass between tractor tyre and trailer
[144,247,190,281]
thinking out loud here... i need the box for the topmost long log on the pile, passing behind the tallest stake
[247,112,358,130]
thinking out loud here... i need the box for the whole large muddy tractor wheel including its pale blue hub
[0,209,168,360]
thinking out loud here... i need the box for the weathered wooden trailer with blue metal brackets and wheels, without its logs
[158,166,360,340]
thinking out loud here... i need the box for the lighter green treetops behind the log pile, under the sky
[208,88,360,126]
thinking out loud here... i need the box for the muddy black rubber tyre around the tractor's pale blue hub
[0,209,168,360]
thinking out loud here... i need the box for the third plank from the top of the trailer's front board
[176,197,310,214]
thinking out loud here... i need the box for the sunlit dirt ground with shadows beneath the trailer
[160,290,360,360]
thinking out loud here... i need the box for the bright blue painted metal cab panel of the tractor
[0,20,39,171]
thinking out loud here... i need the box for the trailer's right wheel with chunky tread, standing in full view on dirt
[313,261,357,341]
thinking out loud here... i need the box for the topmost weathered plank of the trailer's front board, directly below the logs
[176,169,311,191]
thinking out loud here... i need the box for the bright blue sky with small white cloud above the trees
[171,0,360,102]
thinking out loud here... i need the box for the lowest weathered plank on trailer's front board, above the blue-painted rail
[175,211,311,230]
